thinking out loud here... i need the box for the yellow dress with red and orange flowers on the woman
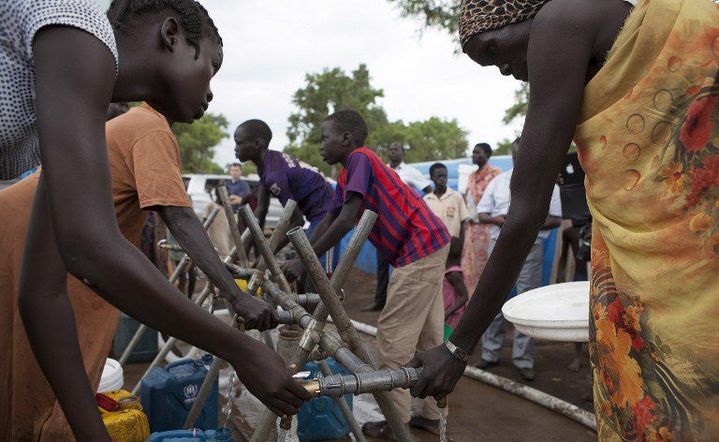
[575,0,719,441]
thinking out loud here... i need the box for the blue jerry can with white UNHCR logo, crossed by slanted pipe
[140,355,218,431]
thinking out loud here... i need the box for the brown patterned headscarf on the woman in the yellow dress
[459,0,549,47]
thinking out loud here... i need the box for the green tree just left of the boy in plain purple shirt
[172,113,229,173]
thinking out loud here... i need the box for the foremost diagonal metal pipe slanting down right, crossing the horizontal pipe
[287,218,412,442]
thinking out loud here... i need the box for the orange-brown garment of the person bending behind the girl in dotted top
[0,104,191,441]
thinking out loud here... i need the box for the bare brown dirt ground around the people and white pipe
[125,271,596,442]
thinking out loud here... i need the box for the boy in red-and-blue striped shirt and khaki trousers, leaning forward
[284,110,450,439]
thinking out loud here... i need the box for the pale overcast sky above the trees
[202,0,519,165]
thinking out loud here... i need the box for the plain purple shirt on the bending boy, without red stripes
[257,150,333,223]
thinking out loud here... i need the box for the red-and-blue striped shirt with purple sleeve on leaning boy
[332,147,450,267]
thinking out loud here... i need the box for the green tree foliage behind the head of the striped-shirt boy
[285,64,467,174]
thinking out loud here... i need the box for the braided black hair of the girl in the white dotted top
[107,0,222,59]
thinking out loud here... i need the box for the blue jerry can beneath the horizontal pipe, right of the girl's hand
[297,358,352,442]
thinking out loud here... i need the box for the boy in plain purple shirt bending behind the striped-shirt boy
[235,120,334,252]
